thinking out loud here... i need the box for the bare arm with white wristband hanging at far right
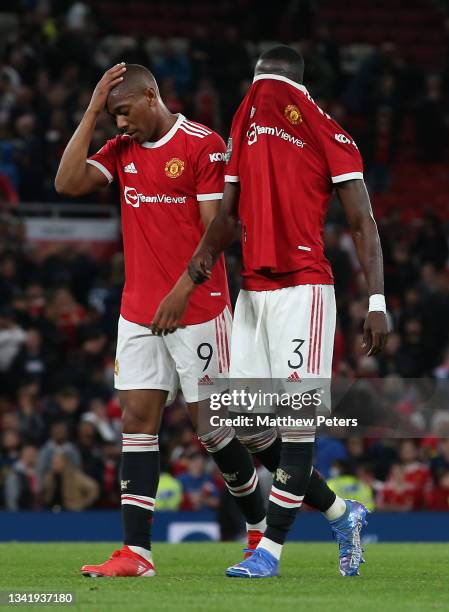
[337,180,388,355]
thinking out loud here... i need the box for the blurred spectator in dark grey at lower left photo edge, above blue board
[5,446,39,511]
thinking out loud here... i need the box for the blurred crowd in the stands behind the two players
[0,0,449,514]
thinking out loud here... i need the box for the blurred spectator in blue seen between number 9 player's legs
[179,453,219,510]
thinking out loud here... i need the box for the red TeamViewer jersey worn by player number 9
[87,115,229,325]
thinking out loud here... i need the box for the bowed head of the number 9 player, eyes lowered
[106,64,176,143]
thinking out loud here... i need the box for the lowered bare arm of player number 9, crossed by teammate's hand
[152,200,228,335]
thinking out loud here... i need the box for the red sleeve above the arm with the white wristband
[317,115,363,183]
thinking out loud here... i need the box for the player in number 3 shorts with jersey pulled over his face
[153,46,387,578]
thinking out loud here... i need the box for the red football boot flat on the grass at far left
[81,546,156,578]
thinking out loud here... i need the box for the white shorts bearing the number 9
[115,307,232,403]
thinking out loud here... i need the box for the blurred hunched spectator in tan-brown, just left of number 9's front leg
[42,452,100,511]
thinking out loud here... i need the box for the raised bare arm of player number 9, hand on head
[55,63,126,197]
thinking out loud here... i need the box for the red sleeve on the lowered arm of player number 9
[194,132,226,202]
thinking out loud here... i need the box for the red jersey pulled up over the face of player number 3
[225,74,363,291]
